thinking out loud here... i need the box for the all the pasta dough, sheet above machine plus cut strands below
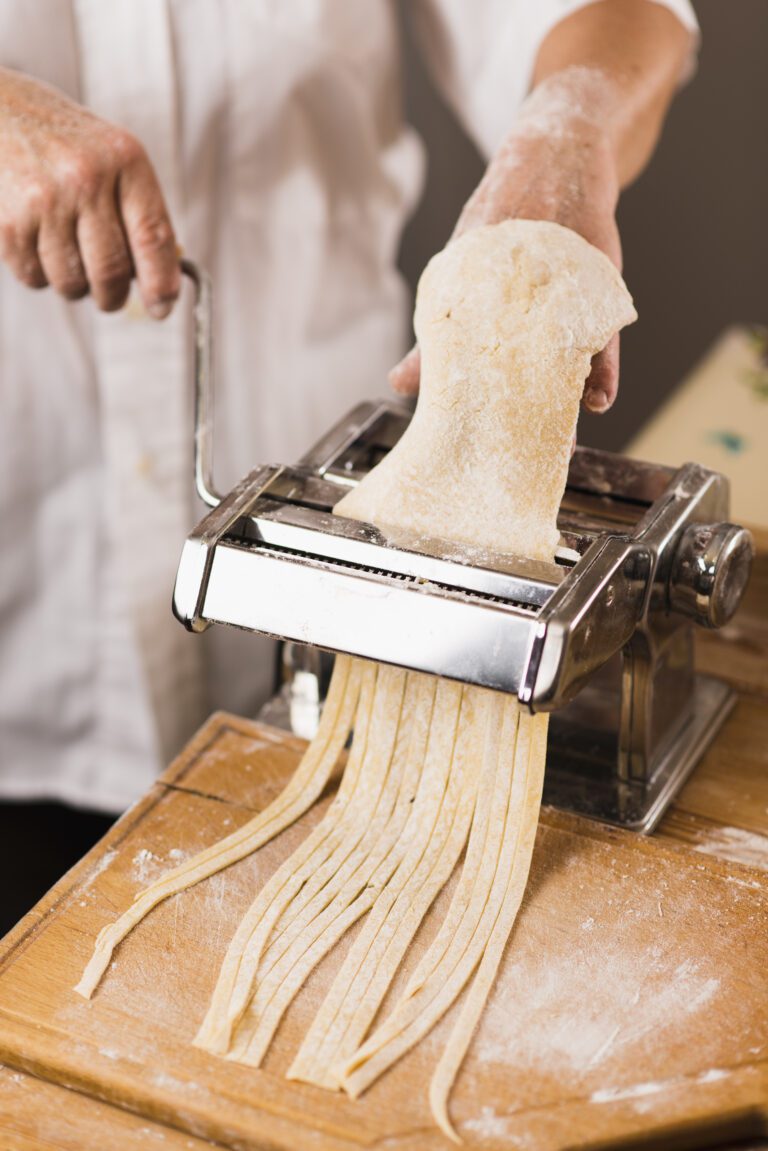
[78,220,634,1137]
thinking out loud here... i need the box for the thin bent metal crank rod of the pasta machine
[181,260,221,508]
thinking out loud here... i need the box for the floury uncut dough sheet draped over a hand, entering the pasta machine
[336,220,637,559]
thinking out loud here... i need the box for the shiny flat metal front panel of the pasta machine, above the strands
[201,542,535,694]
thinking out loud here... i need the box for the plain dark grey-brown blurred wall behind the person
[401,0,768,451]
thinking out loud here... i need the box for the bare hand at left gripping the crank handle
[0,69,181,319]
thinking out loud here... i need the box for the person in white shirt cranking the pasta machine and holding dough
[0,0,698,930]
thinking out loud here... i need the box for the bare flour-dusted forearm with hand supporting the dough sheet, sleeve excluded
[390,0,691,412]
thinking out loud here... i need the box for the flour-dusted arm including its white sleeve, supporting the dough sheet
[391,0,695,412]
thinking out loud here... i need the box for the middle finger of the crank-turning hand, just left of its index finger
[77,189,134,312]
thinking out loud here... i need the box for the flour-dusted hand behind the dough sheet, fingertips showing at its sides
[389,68,622,412]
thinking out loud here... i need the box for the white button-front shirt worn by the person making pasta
[0,0,695,810]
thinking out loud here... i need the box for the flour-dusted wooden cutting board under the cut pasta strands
[0,700,768,1151]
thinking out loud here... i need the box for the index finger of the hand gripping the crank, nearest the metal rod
[117,140,181,320]
